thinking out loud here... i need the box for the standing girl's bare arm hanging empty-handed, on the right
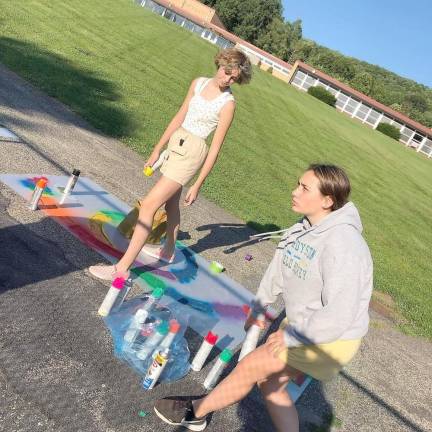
[185,101,235,205]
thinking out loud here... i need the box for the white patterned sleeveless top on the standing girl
[182,78,234,139]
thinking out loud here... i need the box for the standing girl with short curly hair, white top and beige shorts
[89,48,252,280]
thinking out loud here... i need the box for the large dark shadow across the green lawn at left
[0,37,135,138]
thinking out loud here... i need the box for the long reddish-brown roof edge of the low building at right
[294,61,432,137]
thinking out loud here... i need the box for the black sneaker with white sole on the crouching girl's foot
[154,398,207,431]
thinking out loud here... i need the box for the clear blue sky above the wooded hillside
[282,0,432,87]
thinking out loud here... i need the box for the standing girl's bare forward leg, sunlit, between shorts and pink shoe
[116,176,182,272]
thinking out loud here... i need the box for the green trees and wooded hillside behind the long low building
[202,0,432,127]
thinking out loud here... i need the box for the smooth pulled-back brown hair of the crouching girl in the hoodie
[307,163,351,211]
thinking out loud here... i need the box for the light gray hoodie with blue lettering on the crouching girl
[254,202,373,347]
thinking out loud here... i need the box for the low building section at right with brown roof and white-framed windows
[288,61,432,157]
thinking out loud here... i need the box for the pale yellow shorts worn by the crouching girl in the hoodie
[279,320,361,381]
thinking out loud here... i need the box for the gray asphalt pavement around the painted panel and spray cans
[0,65,432,432]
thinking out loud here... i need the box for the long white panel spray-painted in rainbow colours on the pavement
[0,174,307,399]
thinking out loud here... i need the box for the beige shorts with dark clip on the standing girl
[161,128,208,186]
